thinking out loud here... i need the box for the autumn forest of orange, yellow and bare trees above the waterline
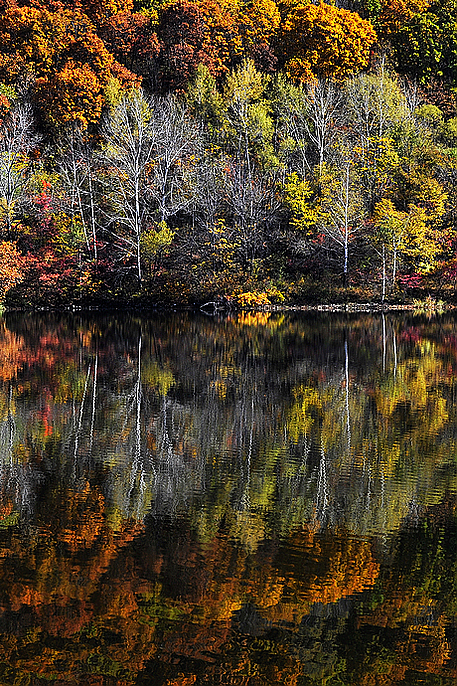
[0,0,457,309]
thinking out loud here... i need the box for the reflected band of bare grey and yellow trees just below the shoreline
[0,315,456,549]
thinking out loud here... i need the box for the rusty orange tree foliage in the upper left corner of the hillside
[0,7,139,127]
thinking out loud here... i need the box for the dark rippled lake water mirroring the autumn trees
[0,314,457,686]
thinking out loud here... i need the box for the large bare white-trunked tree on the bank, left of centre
[102,91,198,284]
